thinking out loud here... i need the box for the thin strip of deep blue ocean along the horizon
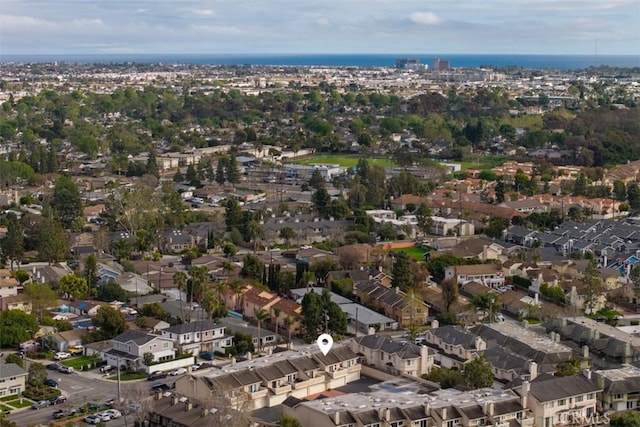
[0,54,640,70]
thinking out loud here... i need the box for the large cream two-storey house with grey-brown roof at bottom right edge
[520,371,602,427]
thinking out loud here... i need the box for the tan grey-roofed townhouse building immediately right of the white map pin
[349,335,436,377]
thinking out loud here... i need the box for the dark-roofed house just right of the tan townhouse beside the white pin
[424,325,487,370]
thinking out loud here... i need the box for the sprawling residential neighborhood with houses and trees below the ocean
[0,58,640,427]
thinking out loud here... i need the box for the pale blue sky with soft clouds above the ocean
[0,0,640,55]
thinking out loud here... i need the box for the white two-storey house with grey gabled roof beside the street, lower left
[101,330,176,369]
